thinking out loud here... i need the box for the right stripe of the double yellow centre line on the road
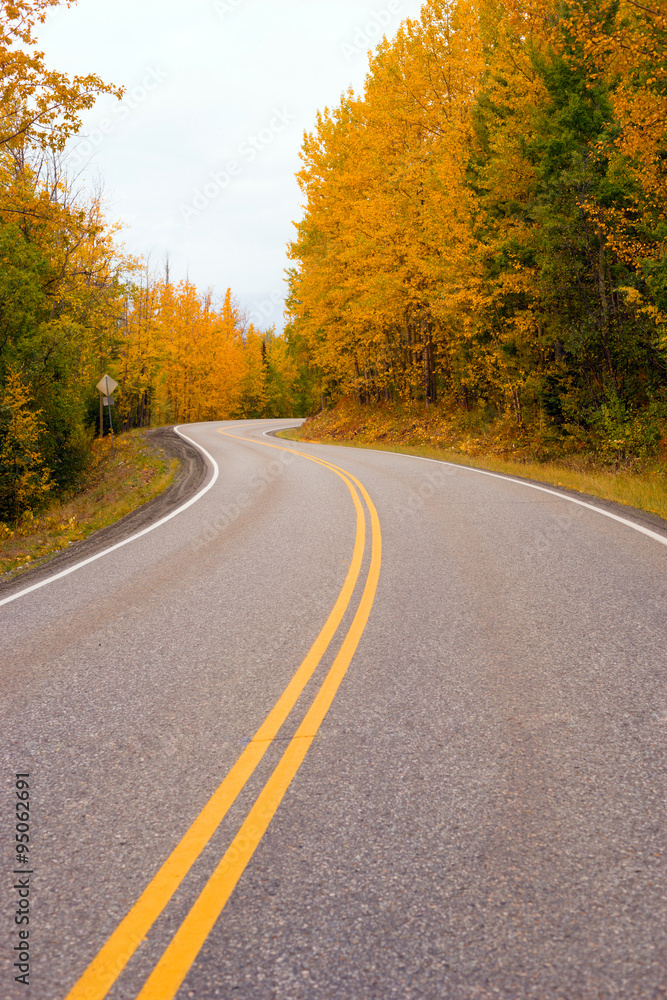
[137,452,382,1000]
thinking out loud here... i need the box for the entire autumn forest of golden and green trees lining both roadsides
[0,0,667,522]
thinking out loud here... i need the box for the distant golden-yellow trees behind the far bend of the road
[114,278,297,427]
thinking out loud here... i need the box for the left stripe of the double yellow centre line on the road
[65,434,366,1000]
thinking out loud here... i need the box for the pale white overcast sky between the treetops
[39,0,423,329]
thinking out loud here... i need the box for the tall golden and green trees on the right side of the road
[288,0,667,462]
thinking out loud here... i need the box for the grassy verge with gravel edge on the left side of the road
[0,431,180,580]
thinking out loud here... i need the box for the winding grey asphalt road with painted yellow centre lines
[0,421,667,1000]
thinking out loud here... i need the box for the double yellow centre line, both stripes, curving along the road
[65,431,382,1000]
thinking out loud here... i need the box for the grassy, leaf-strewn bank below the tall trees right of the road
[279,407,667,519]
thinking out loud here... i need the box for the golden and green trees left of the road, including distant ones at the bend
[0,0,301,523]
